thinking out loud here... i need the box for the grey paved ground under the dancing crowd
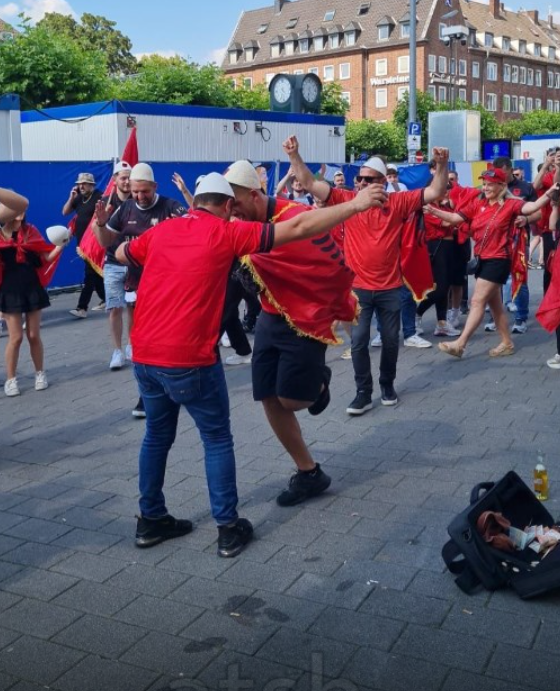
[0,271,560,691]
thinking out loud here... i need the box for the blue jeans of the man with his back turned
[134,362,238,525]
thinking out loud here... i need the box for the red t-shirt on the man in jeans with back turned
[126,209,274,367]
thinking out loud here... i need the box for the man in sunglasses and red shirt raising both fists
[284,137,449,415]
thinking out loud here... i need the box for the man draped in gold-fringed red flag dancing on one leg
[225,161,386,506]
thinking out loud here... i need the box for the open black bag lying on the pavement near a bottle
[441,471,560,599]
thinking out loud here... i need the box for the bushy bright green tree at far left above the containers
[0,15,109,109]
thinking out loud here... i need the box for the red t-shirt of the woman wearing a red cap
[458,198,525,259]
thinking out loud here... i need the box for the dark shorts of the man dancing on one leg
[252,312,327,401]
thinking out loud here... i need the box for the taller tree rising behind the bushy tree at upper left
[37,12,137,74]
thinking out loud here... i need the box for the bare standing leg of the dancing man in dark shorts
[262,396,315,471]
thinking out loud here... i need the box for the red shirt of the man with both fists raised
[327,188,424,290]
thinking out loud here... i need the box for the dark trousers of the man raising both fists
[352,288,401,395]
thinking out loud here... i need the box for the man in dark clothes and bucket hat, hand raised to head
[62,173,105,319]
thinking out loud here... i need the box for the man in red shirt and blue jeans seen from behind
[115,173,384,557]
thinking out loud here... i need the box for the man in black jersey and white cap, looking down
[93,163,187,418]
